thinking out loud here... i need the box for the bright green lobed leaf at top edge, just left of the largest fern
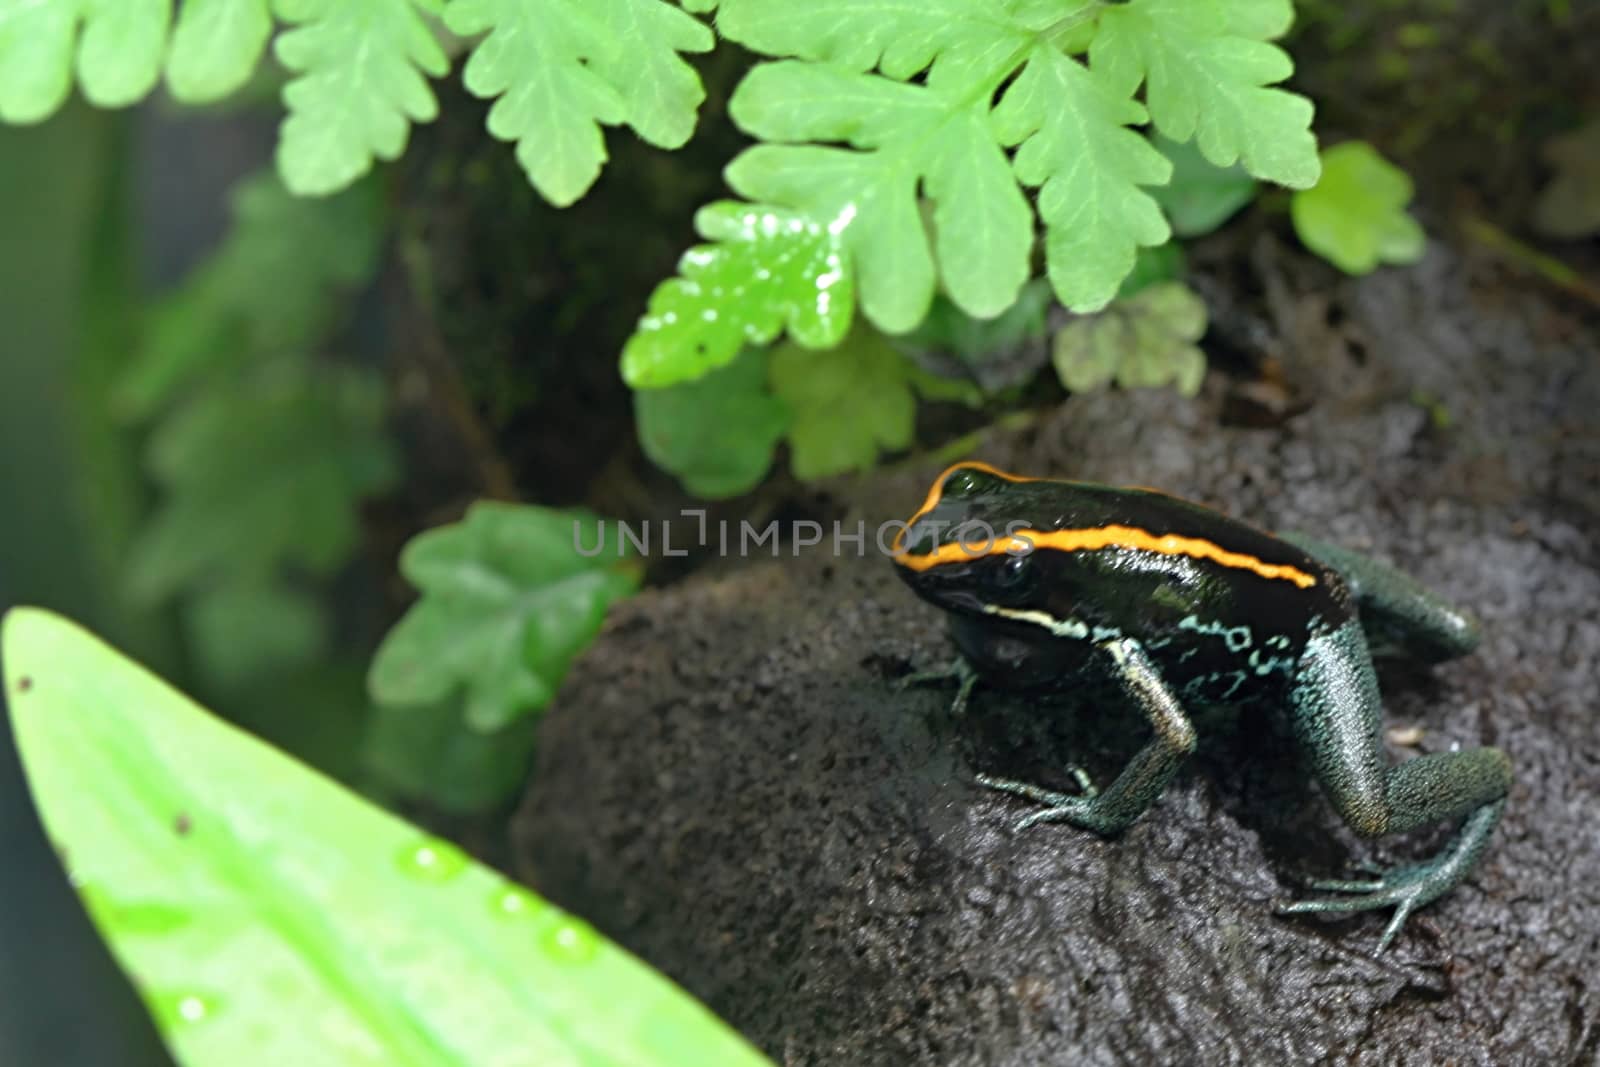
[445,0,715,206]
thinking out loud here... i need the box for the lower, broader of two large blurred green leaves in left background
[128,365,397,601]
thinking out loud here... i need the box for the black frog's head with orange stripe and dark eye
[894,462,1054,614]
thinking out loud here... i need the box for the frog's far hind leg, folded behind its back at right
[1280,534,1478,664]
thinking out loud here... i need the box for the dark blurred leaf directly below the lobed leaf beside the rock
[362,701,536,814]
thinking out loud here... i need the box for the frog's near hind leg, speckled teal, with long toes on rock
[1280,622,1510,952]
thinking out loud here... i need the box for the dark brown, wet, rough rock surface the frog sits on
[515,238,1600,1067]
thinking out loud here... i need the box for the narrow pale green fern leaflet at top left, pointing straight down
[275,0,450,197]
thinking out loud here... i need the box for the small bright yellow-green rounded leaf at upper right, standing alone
[1290,141,1427,274]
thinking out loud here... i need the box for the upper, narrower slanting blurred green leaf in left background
[118,174,382,418]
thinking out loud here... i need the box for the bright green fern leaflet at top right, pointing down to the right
[1090,0,1318,189]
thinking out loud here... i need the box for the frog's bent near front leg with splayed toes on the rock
[978,638,1195,833]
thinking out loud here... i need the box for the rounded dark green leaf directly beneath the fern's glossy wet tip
[634,349,789,499]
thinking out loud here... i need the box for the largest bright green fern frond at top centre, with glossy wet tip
[624,0,1196,386]
